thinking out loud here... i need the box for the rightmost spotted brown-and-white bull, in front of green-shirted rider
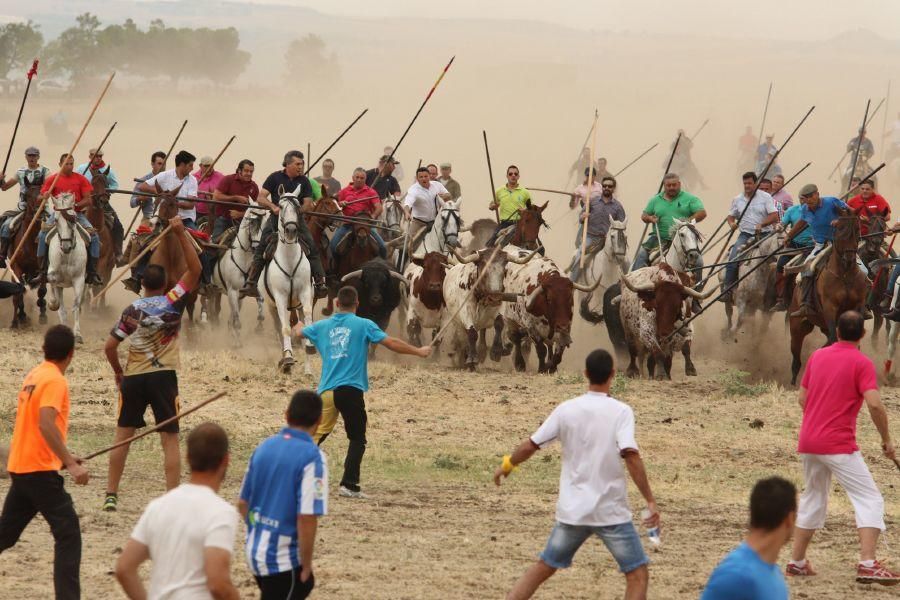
[619,263,718,379]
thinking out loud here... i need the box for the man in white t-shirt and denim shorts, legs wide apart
[494,350,659,600]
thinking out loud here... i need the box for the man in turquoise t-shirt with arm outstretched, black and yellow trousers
[294,286,431,499]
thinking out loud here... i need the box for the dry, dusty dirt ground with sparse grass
[0,301,900,599]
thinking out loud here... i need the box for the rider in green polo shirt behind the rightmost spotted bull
[631,173,706,271]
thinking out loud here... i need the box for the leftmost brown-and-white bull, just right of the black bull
[403,252,449,352]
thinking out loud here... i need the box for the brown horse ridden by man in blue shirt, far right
[790,216,869,385]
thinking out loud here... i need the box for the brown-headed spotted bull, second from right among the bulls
[500,247,600,373]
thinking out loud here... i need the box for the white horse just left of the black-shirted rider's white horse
[211,200,269,343]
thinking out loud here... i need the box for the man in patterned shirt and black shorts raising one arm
[103,217,201,511]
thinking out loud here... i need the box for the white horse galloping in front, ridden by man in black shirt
[261,193,314,375]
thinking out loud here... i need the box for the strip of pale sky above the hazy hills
[236,0,900,39]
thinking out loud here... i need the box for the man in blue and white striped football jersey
[238,390,328,600]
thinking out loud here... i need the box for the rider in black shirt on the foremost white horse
[240,150,328,298]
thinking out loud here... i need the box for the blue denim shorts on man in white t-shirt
[540,521,650,573]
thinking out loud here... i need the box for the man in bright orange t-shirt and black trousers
[0,325,88,599]
